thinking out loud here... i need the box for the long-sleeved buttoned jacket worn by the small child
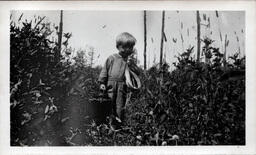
[98,53,127,84]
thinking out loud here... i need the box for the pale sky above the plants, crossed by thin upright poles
[11,10,245,68]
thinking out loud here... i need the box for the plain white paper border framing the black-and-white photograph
[0,0,256,155]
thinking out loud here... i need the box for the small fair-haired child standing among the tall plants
[98,32,136,124]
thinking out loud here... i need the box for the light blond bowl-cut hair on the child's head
[116,32,137,48]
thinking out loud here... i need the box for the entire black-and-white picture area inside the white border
[10,10,246,146]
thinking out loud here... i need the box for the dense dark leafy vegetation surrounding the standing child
[10,18,245,146]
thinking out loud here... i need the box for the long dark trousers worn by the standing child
[107,81,127,122]
